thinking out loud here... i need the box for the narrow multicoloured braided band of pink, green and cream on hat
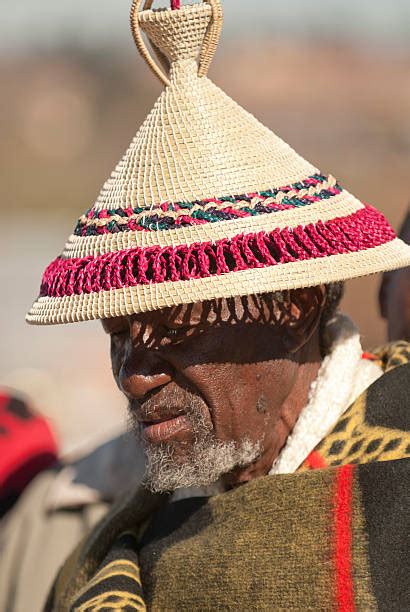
[74,174,342,237]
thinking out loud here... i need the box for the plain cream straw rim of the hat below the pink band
[26,238,410,325]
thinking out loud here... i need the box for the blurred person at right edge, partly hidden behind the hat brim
[379,210,410,342]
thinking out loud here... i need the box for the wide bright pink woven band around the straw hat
[40,206,396,297]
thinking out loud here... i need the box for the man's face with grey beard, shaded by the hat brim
[103,296,318,490]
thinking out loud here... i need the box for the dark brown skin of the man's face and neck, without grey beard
[102,287,325,487]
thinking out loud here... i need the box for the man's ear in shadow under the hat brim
[283,285,326,353]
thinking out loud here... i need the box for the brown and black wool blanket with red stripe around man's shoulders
[46,344,410,612]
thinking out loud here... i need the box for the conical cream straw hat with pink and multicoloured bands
[27,0,410,324]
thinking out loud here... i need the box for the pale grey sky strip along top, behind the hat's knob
[0,0,410,51]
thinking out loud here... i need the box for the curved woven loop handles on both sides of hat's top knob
[130,0,223,86]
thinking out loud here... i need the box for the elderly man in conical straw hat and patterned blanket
[28,0,410,611]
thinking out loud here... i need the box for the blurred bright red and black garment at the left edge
[0,390,58,516]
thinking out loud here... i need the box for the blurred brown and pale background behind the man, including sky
[0,0,410,454]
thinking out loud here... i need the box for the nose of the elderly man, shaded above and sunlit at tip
[118,351,172,400]
